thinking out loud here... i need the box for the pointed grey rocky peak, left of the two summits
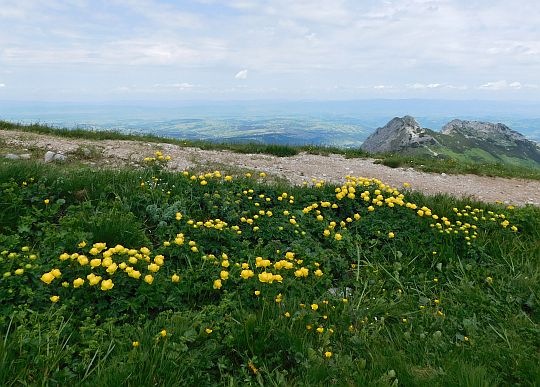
[361,116,437,153]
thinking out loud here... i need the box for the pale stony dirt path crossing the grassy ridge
[0,130,540,206]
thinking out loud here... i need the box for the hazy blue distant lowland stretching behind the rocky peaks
[0,98,540,143]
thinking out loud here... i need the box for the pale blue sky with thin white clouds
[0,0,540,102]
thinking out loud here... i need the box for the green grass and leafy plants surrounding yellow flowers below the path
[0,162,540,386]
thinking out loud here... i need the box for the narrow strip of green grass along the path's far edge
[0,121,540,180]
